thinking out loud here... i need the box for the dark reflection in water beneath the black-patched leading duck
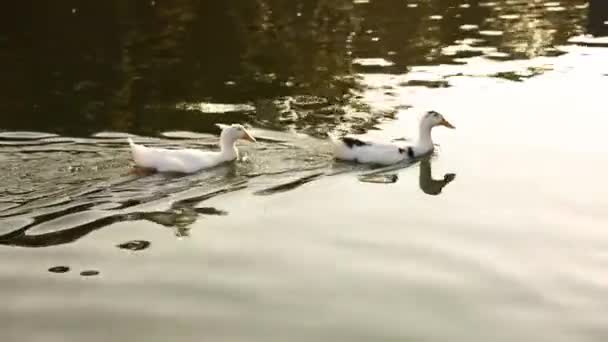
[359,156,456,196]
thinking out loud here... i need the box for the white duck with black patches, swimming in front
[330,111,455,165]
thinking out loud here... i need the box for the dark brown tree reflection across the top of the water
[0,0,601,135]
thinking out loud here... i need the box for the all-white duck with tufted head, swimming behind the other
[128,124,255,173]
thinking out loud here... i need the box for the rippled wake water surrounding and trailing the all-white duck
[0,132,338,249]
